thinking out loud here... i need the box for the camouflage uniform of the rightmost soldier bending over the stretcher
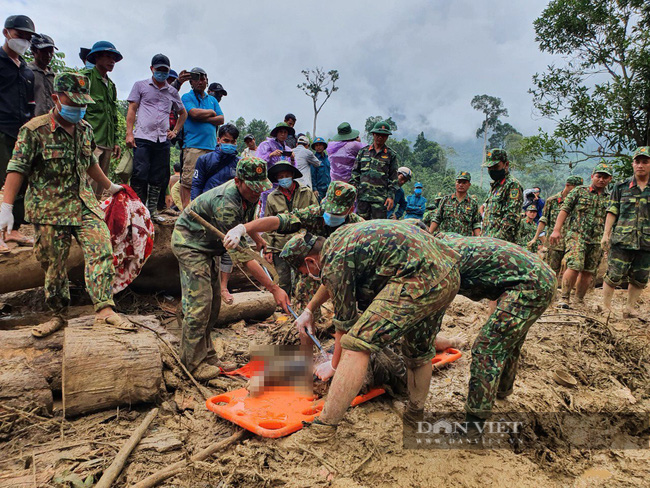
[440,234,557,418]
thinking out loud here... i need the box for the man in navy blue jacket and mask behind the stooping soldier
[191,124,239,304]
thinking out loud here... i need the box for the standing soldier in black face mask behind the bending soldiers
[481,149,524,242]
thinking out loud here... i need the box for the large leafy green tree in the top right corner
[530,0,650,174]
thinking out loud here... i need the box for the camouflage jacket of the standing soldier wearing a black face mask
[482,173,524,242]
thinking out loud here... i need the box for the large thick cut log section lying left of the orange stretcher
[63,317,163,417]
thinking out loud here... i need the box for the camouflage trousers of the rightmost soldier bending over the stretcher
[465,268,557,419]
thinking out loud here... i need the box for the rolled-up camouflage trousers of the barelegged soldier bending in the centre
[341,269,460,368]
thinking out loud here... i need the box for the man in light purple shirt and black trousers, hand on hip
[126,54,187,222]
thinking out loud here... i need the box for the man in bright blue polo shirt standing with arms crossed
[181,68,224,207]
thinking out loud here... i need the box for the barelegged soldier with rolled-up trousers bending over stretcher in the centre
[280,221,459,438]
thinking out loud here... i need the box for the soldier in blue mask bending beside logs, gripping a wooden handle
[171,158,289,380]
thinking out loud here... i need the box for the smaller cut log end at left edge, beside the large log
[0,358,54,414]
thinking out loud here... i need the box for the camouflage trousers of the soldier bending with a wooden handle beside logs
[172,229,221,372]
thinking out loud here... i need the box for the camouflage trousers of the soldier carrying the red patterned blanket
[34,209,115,314]
